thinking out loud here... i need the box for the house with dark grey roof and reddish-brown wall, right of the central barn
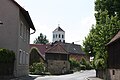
[60,42,89,62]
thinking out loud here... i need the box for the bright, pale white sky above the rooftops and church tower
[16,0,95,45]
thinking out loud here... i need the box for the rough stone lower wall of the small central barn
[47,60,70,74]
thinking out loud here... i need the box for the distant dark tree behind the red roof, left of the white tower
[34,33,49,44]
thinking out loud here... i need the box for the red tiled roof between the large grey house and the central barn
[30,44,51,58]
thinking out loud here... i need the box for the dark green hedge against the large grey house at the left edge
[0,49,15,76]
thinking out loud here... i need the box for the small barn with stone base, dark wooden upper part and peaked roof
[45,43,70,74]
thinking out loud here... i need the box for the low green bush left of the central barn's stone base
[29,63,45,74]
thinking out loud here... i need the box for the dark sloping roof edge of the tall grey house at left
[10,0,36,30]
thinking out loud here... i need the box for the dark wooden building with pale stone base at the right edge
[107,31,120,80]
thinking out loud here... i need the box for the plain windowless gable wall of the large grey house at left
[0,0,19,77]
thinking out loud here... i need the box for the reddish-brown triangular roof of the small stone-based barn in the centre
[46,43,68,54]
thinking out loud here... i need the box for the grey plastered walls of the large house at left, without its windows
[0,0,29,77]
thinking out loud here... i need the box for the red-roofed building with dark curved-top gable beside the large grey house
[29,44,51,65]
